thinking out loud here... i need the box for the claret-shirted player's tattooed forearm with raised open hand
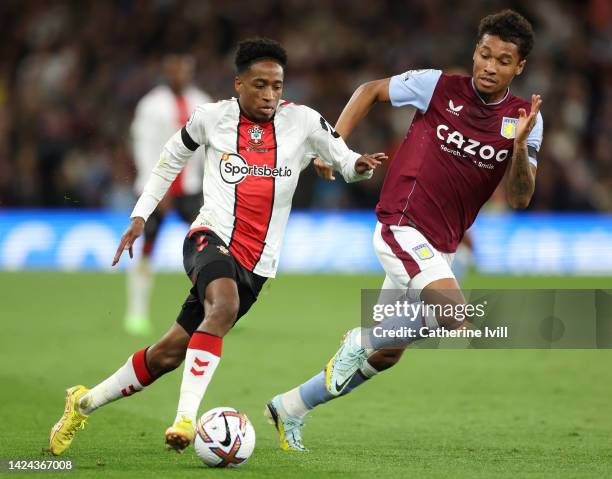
[506,95,542,209]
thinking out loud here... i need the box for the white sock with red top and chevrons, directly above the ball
[175,331,223,424]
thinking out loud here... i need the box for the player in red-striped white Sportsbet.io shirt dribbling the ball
[49,39,386,455]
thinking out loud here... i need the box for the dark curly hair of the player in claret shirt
[478,9,535,59]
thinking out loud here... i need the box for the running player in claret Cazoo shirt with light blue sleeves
[265,10,543,450]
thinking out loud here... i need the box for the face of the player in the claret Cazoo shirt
[472,34,525,100]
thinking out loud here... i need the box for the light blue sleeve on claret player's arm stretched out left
[389,70,442,113]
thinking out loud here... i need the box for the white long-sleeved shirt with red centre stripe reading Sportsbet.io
[132,99,372,277]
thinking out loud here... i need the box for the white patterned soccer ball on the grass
[194,407,255,467]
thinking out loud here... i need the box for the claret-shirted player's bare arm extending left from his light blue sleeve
[335,78,390,139]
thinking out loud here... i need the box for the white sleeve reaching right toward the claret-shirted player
[305,107,373,183]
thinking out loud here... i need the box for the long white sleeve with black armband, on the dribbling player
[130,107,206,221]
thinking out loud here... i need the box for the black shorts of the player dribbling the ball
[176,229,267,336]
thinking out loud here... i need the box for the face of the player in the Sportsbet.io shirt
[235,60,284,122]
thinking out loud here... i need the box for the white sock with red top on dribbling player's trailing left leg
[79,348,155,415]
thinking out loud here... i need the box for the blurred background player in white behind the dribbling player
[124,53,211,335]
